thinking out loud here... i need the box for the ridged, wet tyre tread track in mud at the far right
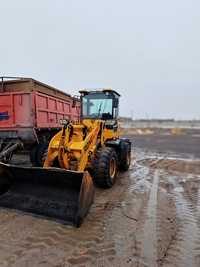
[161,174,200,267]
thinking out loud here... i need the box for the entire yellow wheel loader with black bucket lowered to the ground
[0,89,131,226]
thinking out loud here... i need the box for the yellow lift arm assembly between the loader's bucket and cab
[44,120,104,171]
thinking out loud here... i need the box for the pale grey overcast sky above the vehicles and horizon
[0,0,200,119]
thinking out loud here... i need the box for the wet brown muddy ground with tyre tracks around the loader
[0,136,200,267]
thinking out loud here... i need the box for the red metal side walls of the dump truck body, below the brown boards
[0,92,80,129]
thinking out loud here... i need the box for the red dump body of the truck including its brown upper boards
[0,79,80,141]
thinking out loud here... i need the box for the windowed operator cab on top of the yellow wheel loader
[80,89,120,120]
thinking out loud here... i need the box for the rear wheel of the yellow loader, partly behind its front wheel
[119,141,131,172]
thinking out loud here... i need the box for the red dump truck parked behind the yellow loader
[0,77,80,166]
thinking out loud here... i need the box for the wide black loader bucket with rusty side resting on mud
[0,163,94,227]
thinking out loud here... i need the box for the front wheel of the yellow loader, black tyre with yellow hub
[93,147,117,188]
